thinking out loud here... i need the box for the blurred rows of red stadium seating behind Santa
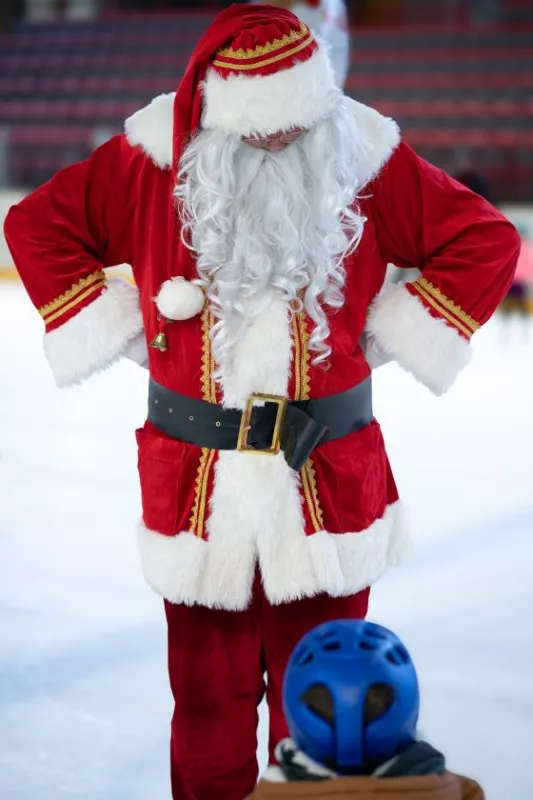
[0,12,533,201]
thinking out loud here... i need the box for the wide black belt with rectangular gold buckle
[148,377,373,470]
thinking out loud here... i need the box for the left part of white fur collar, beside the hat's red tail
[124,92,176,169]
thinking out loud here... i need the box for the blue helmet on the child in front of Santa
[283,620,420,774]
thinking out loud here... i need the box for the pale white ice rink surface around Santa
[0,284,533,800]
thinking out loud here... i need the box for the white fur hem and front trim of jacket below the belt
[138,504,409,611]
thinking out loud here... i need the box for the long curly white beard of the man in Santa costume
[175,100,365,374]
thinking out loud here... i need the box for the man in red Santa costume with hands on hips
[5,5,519,800]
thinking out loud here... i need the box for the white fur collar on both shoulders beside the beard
[125,92,400,189]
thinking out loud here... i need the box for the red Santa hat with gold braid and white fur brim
[174,5,338,172]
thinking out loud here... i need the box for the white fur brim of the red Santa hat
[202,45,334,136]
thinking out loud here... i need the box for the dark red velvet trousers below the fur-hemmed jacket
[166,579,369,800]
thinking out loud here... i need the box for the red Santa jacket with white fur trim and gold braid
[5,95,519,609]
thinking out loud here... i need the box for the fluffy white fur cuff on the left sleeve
[44,279,143,386]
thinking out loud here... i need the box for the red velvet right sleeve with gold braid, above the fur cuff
[373,143,520,339]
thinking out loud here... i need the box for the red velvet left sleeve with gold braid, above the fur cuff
[4,136,135,332]
